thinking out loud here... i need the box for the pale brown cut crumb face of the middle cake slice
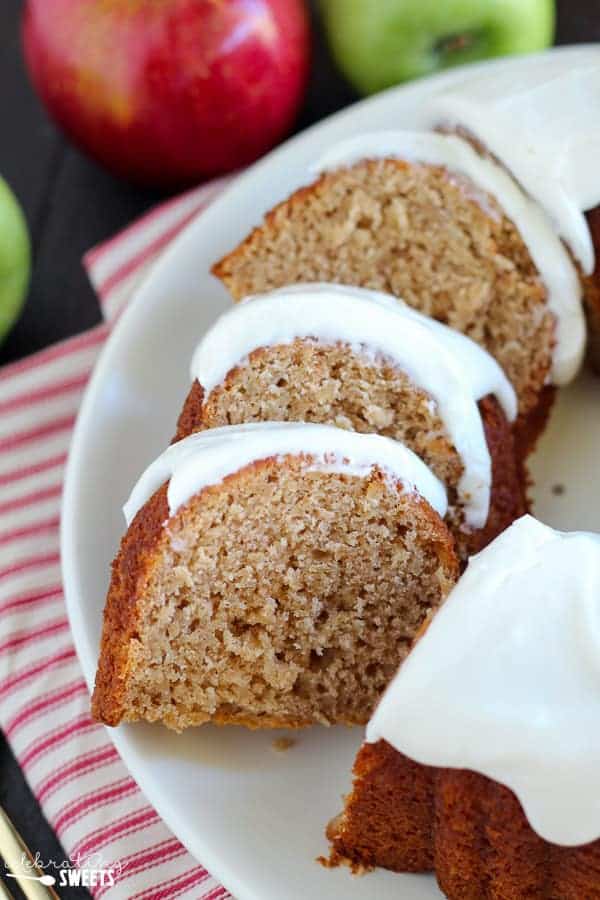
[185,339,463,490]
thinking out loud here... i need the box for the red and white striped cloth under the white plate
[0,179,237,900]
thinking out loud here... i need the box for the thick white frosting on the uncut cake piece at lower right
[367,516,600,846]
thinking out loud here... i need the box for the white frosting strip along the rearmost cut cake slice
[315,131,586,385]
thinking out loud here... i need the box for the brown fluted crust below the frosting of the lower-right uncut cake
[327,741,600,900]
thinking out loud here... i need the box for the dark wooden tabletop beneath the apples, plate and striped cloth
[0,0,600,898]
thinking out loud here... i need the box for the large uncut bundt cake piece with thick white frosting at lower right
[328,516,600,900]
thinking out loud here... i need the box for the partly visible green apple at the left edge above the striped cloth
[0,178,31,340]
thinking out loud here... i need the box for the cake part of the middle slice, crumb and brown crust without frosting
[177,339,526,561]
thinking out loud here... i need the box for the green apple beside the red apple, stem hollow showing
[320,0,555,94]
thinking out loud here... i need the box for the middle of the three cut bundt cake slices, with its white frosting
[172,284,526,560]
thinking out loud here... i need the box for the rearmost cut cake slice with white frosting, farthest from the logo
[213,131,585,449]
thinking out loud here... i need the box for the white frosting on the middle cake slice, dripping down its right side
[191,284,517,528]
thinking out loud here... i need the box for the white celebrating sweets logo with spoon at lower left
[4,852,124,888]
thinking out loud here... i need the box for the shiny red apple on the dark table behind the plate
[23,0,310,184]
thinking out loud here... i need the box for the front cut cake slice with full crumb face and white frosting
[92,423,458,730]
